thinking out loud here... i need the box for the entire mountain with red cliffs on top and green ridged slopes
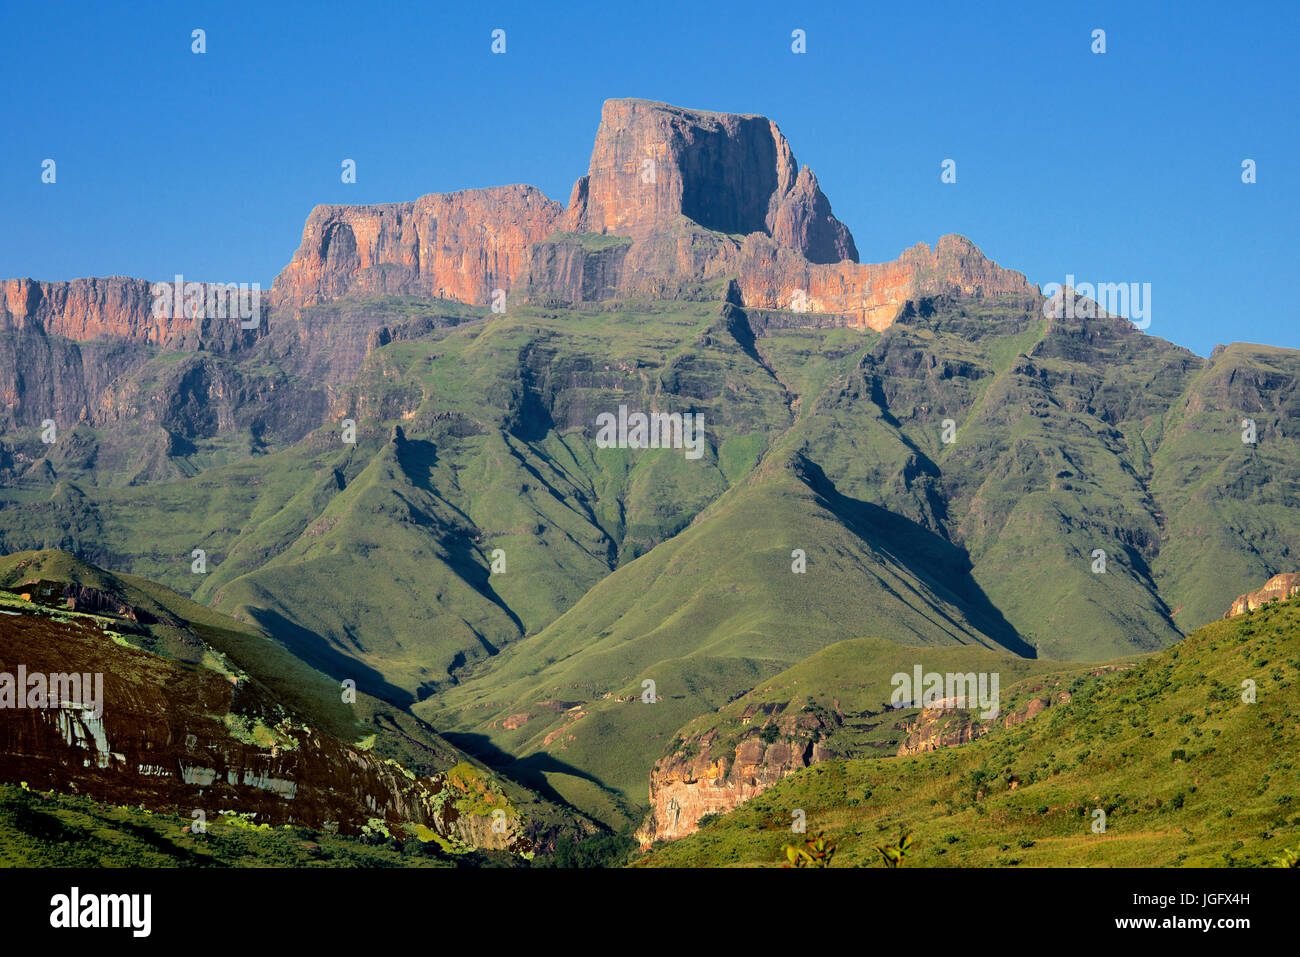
[0,99,1300,852]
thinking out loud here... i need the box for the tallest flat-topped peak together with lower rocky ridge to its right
[543,100,1036,319]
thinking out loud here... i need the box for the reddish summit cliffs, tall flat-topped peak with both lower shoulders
[272,99,1036,329]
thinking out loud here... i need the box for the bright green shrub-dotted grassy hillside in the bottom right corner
[640,599,1300,866]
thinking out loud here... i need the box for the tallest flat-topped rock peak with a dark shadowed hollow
[564,99,858,263]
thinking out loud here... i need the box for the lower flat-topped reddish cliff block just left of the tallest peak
[272,186,562,307]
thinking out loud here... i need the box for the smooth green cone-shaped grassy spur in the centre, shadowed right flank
[426,447,1028,821]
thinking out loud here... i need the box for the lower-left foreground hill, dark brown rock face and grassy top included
[0,553,590,853]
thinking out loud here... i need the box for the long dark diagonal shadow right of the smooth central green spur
[800,456,1037,658]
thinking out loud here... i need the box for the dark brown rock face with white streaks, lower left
[0,595,530,853]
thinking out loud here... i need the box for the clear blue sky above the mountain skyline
[0,0,1300,355]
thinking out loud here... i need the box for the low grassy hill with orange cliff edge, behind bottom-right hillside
[637,638,1127,844]
